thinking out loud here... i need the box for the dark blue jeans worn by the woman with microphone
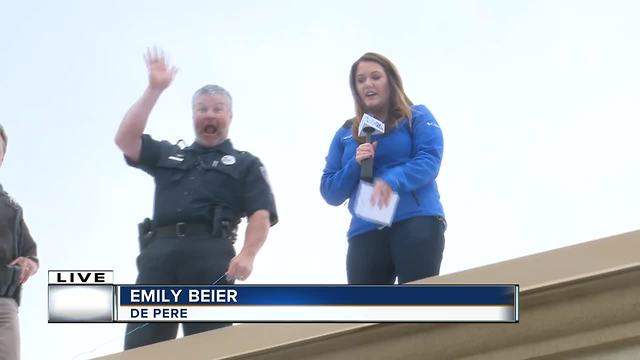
[347,216,446,285]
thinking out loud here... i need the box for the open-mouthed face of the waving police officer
[193,94,233,146]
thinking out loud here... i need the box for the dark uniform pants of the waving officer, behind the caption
[124,235,235,350]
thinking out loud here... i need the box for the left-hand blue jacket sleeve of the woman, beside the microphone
[320,128,360,206]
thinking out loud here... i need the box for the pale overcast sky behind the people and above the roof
[0,0,640,359]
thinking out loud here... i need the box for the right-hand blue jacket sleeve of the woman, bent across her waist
[380,105,444,192]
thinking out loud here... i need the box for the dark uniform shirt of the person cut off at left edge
[0,185,38,265]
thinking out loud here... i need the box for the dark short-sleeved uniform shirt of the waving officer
[125,134,278,226]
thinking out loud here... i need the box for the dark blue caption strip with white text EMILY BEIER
[118,285,518,306]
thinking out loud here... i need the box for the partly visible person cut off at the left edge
[0,125,38,360]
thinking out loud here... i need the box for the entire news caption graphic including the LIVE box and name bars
[49,270,519,323]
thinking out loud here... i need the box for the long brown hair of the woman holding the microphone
[349,52,413,143]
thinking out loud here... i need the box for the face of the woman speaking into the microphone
[356,61,389,113]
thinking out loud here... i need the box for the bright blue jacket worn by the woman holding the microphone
[320,105,444,238]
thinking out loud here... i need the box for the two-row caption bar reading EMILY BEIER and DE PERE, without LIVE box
[117,285,518,323]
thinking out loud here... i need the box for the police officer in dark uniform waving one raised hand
[115,49,278,349]
